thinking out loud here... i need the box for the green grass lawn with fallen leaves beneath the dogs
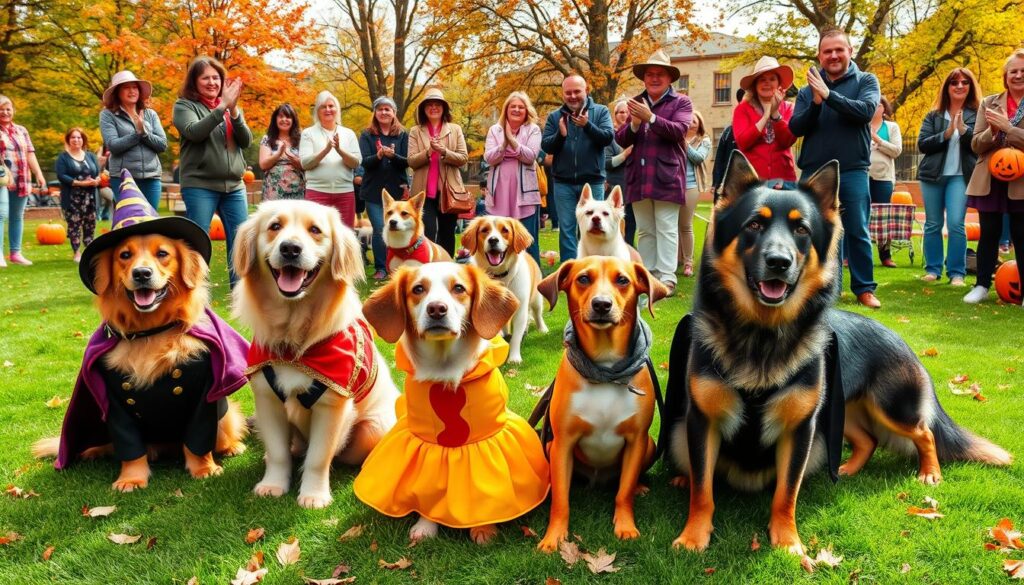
[0,208,1024,584]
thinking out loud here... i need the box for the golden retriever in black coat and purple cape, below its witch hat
[34,232,248,492]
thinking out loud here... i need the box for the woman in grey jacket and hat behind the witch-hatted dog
[99,71,167,209]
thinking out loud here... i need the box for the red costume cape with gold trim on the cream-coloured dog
[246,319,377,409]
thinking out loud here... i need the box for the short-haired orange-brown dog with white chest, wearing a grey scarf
[538,257,668,552]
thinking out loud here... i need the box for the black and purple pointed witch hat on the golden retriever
[78,169,213,294]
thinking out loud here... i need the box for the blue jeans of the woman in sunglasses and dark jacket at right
[921,175,967,278]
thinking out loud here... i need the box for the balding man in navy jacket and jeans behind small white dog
[541,75,614,261]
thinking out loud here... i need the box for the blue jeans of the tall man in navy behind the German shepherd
[823,169,879,295]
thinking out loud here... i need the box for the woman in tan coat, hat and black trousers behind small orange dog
[409,87,469,258]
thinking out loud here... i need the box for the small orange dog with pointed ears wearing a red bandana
[381,189,452,274]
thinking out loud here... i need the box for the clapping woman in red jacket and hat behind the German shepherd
[732,56,797,189]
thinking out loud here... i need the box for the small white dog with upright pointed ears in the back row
[575,184,641,262]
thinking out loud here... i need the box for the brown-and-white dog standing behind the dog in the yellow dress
[462,215,548,364]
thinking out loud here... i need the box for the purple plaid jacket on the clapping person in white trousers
[615,87,693,204]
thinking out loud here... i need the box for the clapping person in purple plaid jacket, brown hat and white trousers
[615,50,693,294]
